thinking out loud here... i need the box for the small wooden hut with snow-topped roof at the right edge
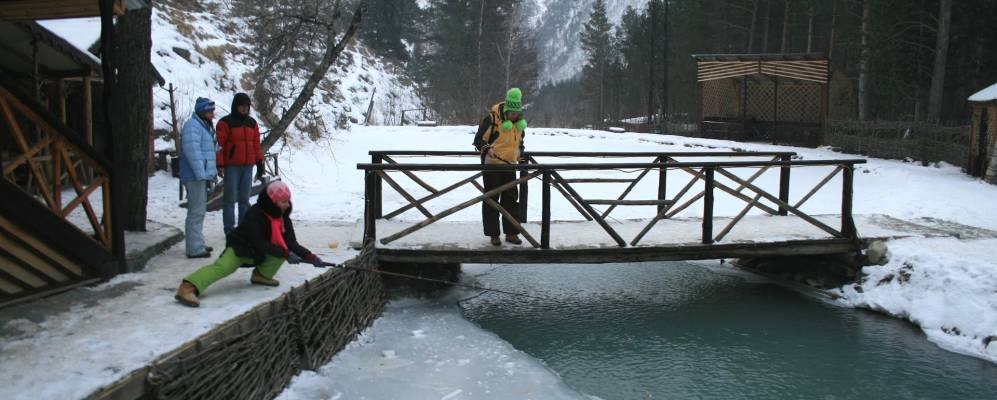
[966,83,997,184]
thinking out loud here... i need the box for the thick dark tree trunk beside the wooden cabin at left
[111,3,154,231]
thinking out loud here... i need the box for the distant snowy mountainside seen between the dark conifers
[537,0,647,82]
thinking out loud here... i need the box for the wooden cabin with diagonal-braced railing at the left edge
[0,0,147,307]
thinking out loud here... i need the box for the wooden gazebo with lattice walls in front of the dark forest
[692,53,830,147]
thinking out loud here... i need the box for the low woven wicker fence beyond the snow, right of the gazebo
[824,121,970,167]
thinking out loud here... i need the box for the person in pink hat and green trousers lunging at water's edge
[176,181,324,307]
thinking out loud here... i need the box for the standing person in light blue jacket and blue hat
[180,97,218,258]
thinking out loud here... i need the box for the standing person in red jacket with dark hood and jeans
[216,93,264,235]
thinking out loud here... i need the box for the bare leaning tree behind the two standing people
[243,0,367,151]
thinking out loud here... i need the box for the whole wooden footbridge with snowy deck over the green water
[353,151,884,263]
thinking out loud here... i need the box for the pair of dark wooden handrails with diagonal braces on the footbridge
[357,151,866,249]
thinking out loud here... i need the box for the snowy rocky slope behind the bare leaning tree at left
[152,0,421,141]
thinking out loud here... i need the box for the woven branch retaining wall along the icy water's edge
[143,252,386,400]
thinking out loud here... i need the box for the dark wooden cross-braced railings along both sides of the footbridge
[357,151,865,249]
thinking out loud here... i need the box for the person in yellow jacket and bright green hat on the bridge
[474,88,526,246]
